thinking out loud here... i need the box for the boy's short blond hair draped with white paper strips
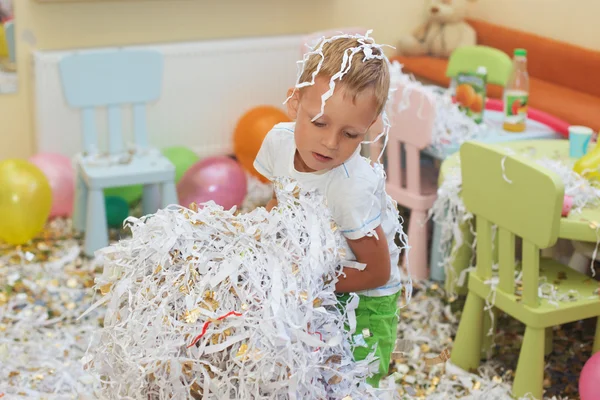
[298,37,390,115]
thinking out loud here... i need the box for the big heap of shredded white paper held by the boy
[84,180,395,399]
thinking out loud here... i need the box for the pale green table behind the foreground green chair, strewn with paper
[439,140,600,293]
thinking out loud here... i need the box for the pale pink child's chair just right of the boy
[378,84,437,279]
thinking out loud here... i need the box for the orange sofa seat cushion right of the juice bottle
[529,78,600,132]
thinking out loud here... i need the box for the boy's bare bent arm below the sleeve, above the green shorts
[335,225,391,293]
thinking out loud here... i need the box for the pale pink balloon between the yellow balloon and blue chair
[29,153,75,218]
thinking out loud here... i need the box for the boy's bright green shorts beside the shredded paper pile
[337,292,400,387]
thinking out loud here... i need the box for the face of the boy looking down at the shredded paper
[287,76,377,172]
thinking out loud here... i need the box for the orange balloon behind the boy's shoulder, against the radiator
[233,106,290,182]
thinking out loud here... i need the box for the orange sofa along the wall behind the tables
[390,19,600,132]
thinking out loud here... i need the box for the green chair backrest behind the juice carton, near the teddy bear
[446,46,512,86]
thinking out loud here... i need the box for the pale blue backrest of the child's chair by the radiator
[59,49,163,154]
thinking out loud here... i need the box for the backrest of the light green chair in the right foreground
[460,142,564,307]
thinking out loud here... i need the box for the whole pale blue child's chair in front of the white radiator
[59,50,177,256]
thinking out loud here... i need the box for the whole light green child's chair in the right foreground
[451,142,600,399]
